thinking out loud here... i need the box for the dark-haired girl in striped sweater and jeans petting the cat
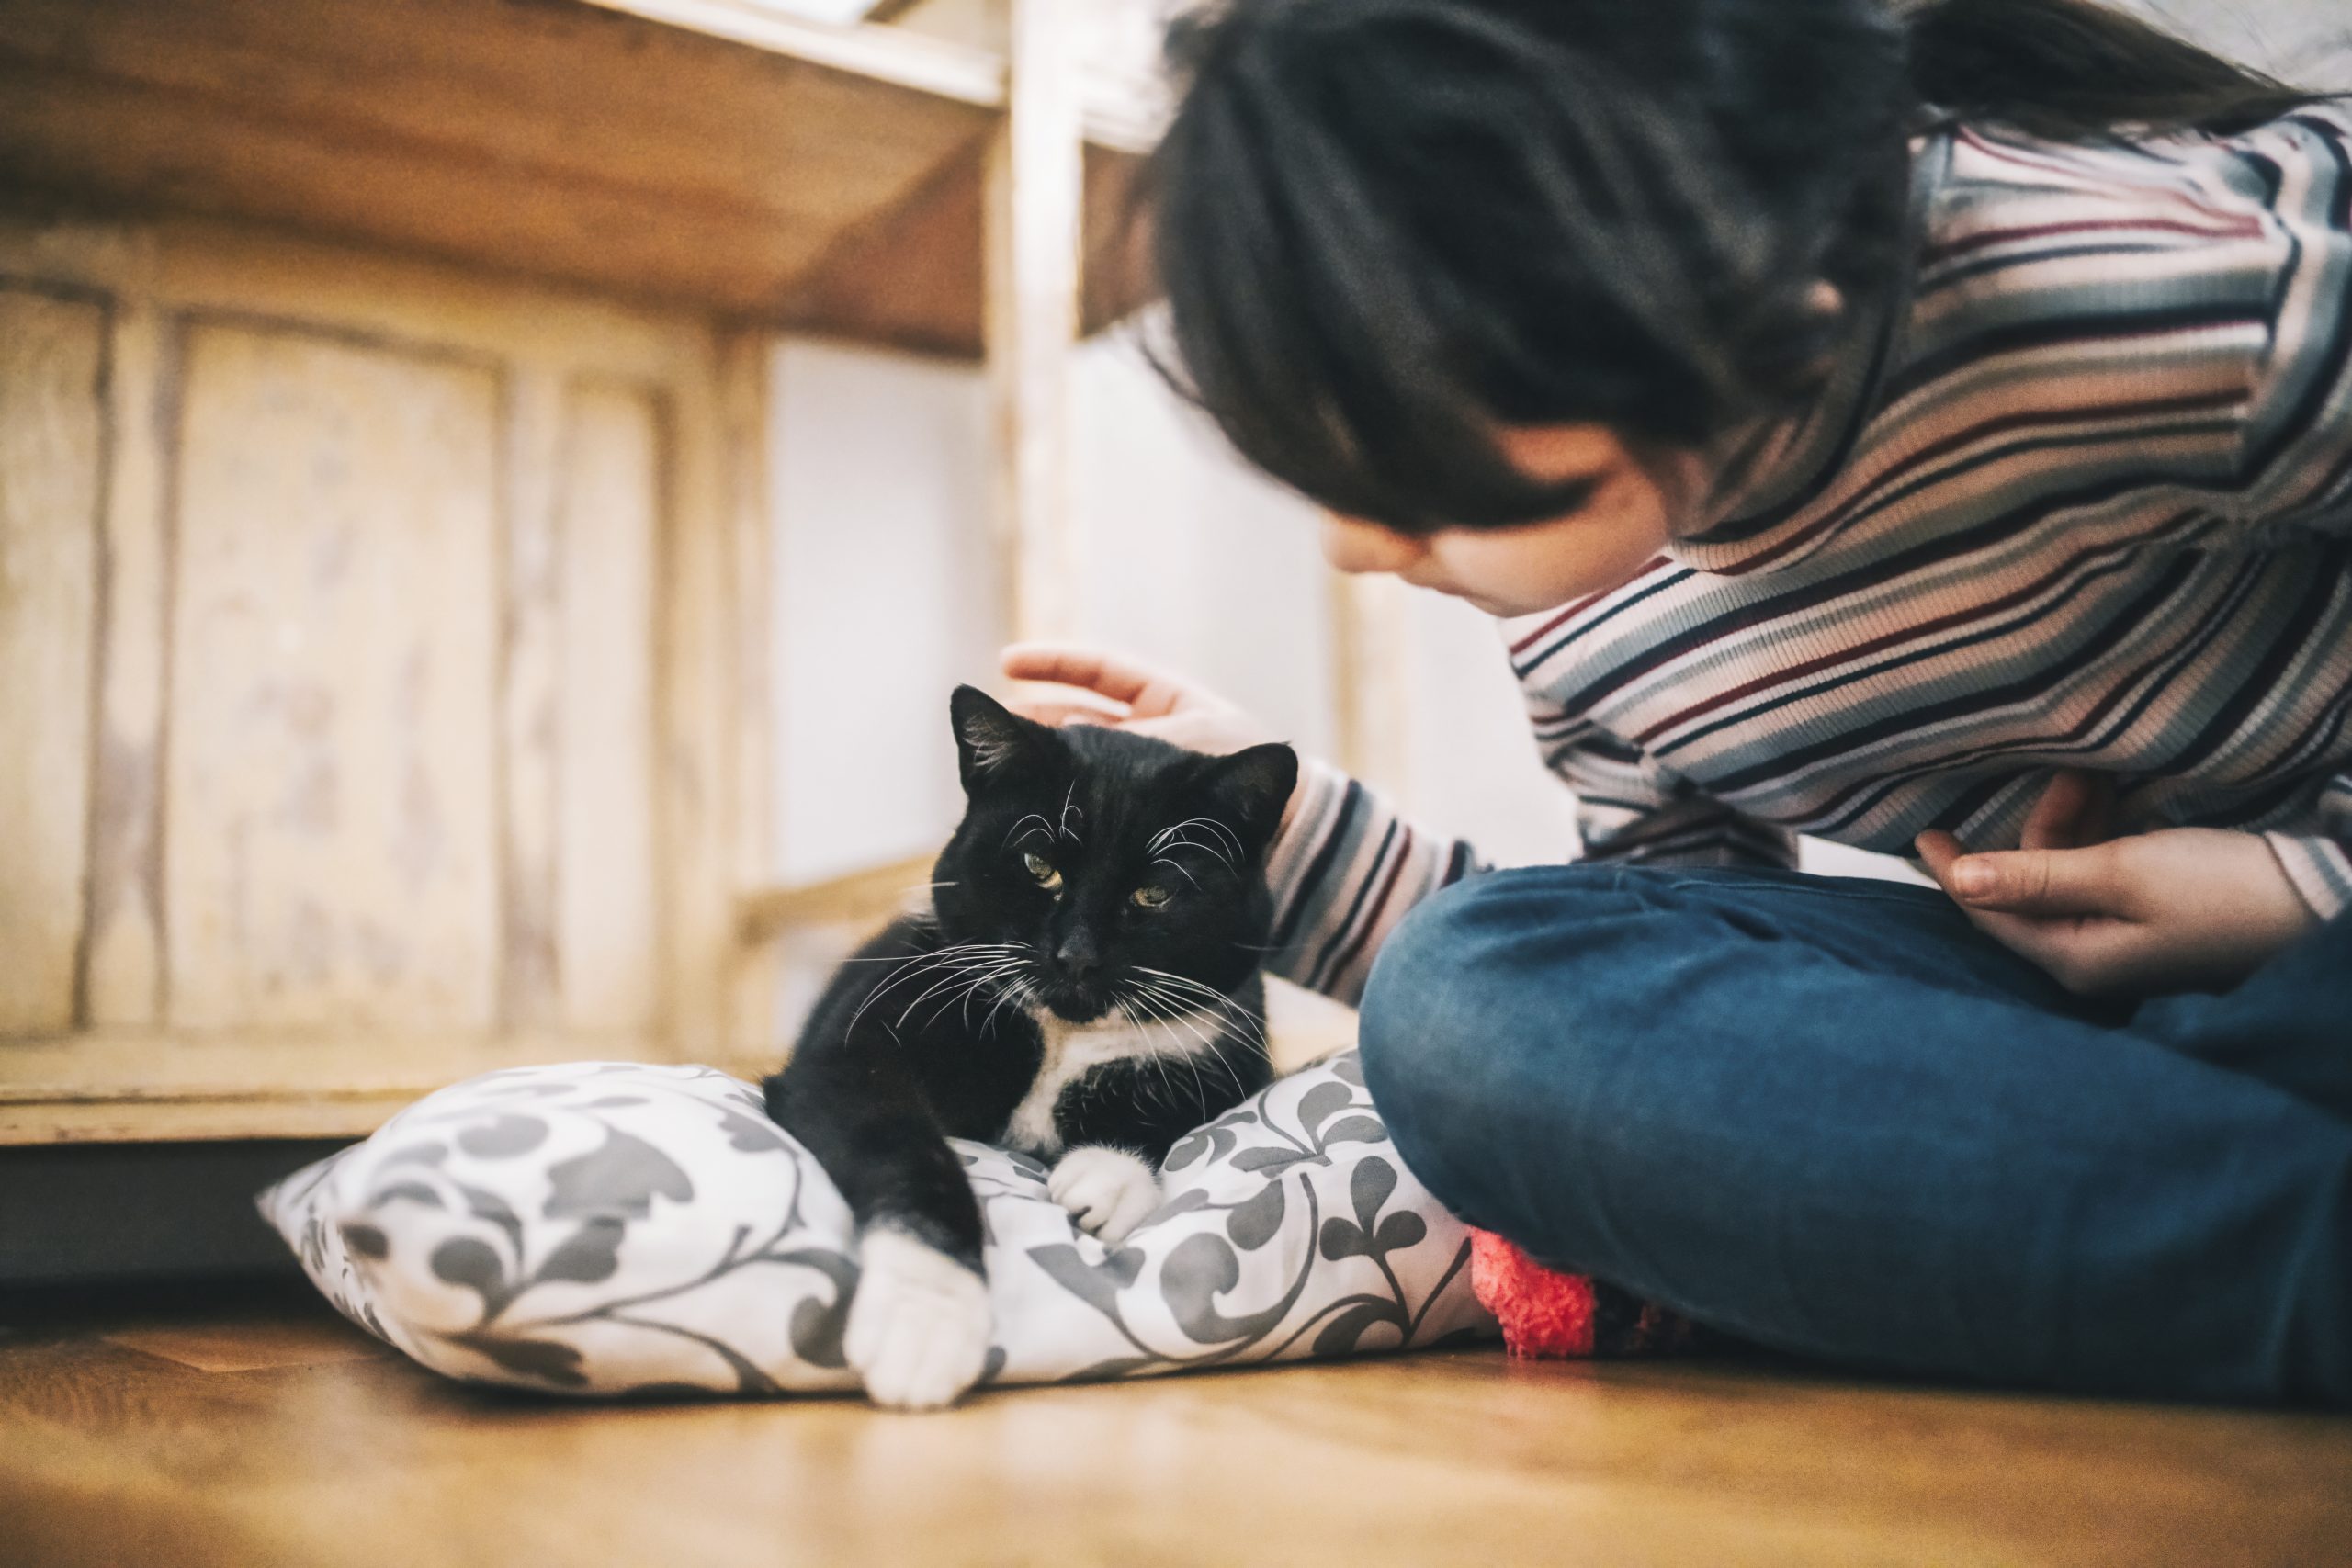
[1007,0,2352,1404]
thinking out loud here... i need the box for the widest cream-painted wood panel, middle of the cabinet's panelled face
[164,324,501,1032]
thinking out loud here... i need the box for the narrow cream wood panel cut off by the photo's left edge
[0,289,106,1034]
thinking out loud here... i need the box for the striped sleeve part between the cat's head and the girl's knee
[1265,761,1487,1006]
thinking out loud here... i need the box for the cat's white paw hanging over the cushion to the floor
[842,1227,990,1411]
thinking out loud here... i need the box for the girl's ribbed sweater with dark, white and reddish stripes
[1270,108,2352,1001]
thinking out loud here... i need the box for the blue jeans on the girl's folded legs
[1362,865,2352,1405]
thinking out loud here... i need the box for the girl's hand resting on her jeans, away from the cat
[1917,771,2314,997]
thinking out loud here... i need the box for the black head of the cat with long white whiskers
[933,686,1298,1022]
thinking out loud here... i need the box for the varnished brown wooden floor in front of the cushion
[0,1293,2352,1568]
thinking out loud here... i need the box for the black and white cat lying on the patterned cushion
[767,686,1298,1408]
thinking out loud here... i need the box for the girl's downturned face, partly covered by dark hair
[1322,425,1702,616]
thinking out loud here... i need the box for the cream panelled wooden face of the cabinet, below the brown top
[0,219,767,1140]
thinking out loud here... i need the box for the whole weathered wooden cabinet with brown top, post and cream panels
[0,0,1131,1143]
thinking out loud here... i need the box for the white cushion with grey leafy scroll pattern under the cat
[256,1054,1496,1394]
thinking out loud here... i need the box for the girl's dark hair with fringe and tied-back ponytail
[1143,0,2319,531]
